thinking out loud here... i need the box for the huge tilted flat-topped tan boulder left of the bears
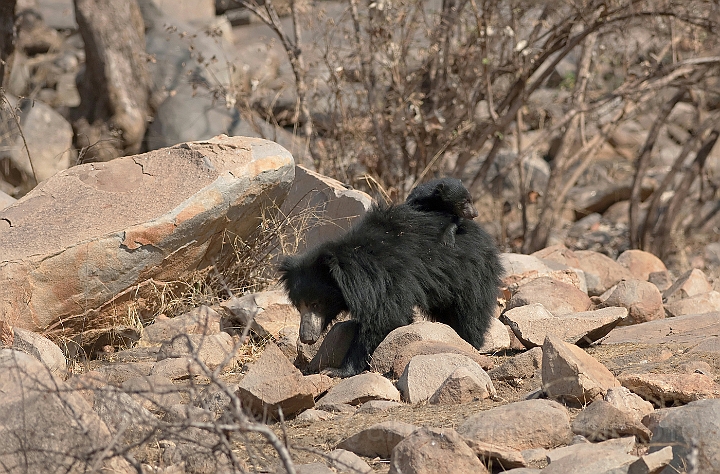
[0,135,295,335]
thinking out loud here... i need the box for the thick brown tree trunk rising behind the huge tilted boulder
[73,0,149,161]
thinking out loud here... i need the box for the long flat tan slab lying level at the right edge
[601,312,720,347]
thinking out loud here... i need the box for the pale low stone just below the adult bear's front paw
[318,372,400,406]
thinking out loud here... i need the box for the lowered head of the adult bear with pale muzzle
[279,251,347,344]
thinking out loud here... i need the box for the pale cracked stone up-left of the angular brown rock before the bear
[157,332,236,370]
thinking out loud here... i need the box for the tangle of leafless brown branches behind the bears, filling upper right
[242,0,719,252]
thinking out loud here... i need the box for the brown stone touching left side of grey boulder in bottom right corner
[572,400,650,443]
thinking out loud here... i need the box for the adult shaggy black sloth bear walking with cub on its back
[279,198,503,377]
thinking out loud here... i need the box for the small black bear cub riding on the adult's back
[405,178,478,245]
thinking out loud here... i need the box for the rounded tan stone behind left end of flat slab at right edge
[598,279,665,325]
